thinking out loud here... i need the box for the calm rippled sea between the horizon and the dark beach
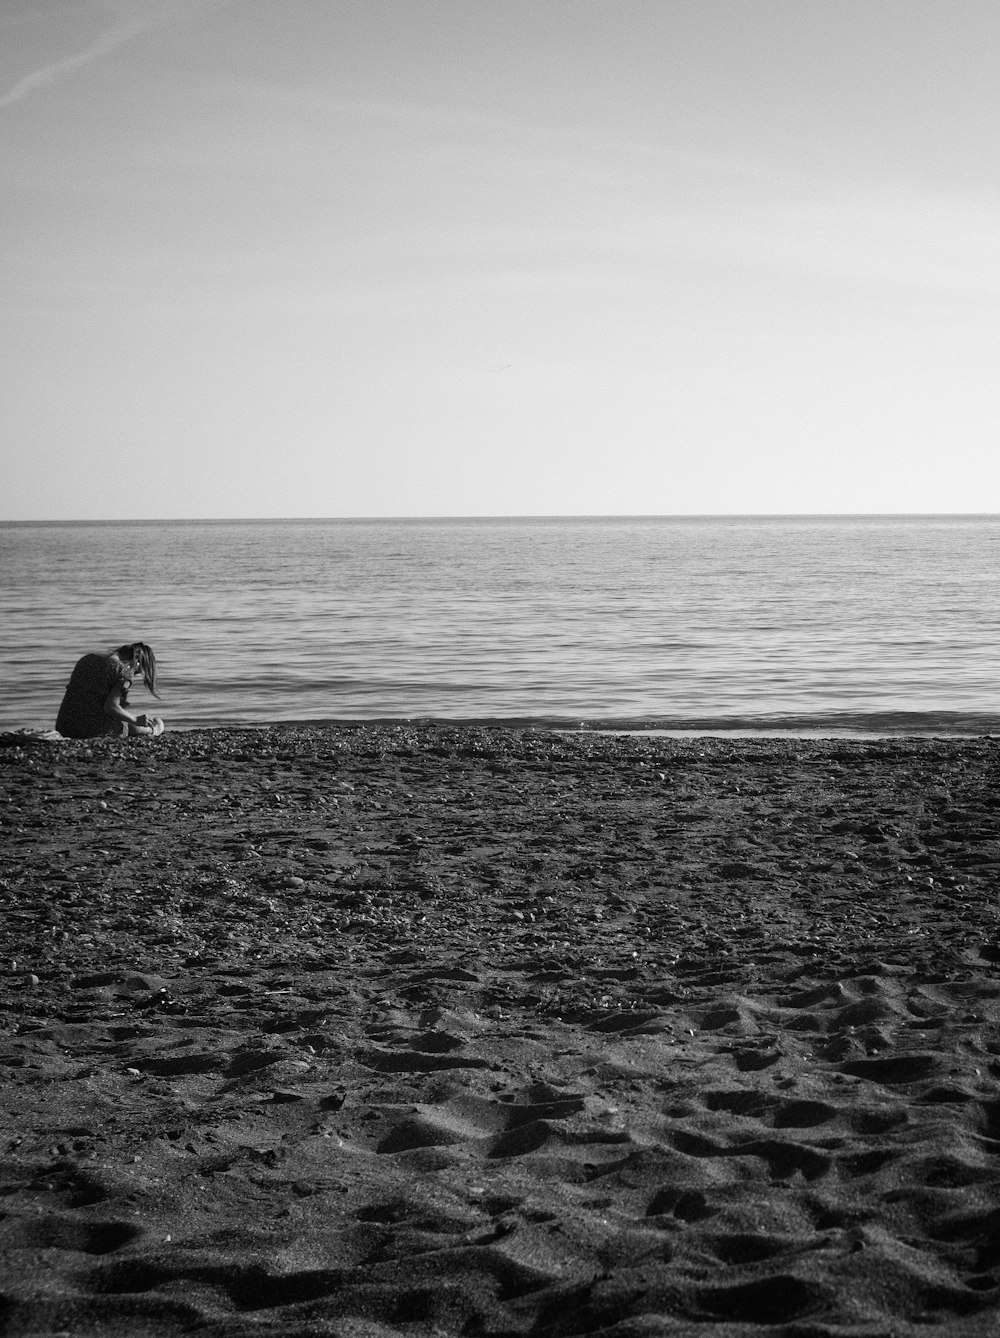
[0,516,1000,731]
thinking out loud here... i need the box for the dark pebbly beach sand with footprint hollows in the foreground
[0,727,1000,1338]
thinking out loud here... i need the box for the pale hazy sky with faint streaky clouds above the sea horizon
[0,0,1000,519]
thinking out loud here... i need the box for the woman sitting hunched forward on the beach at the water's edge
[56,641,163,739]
